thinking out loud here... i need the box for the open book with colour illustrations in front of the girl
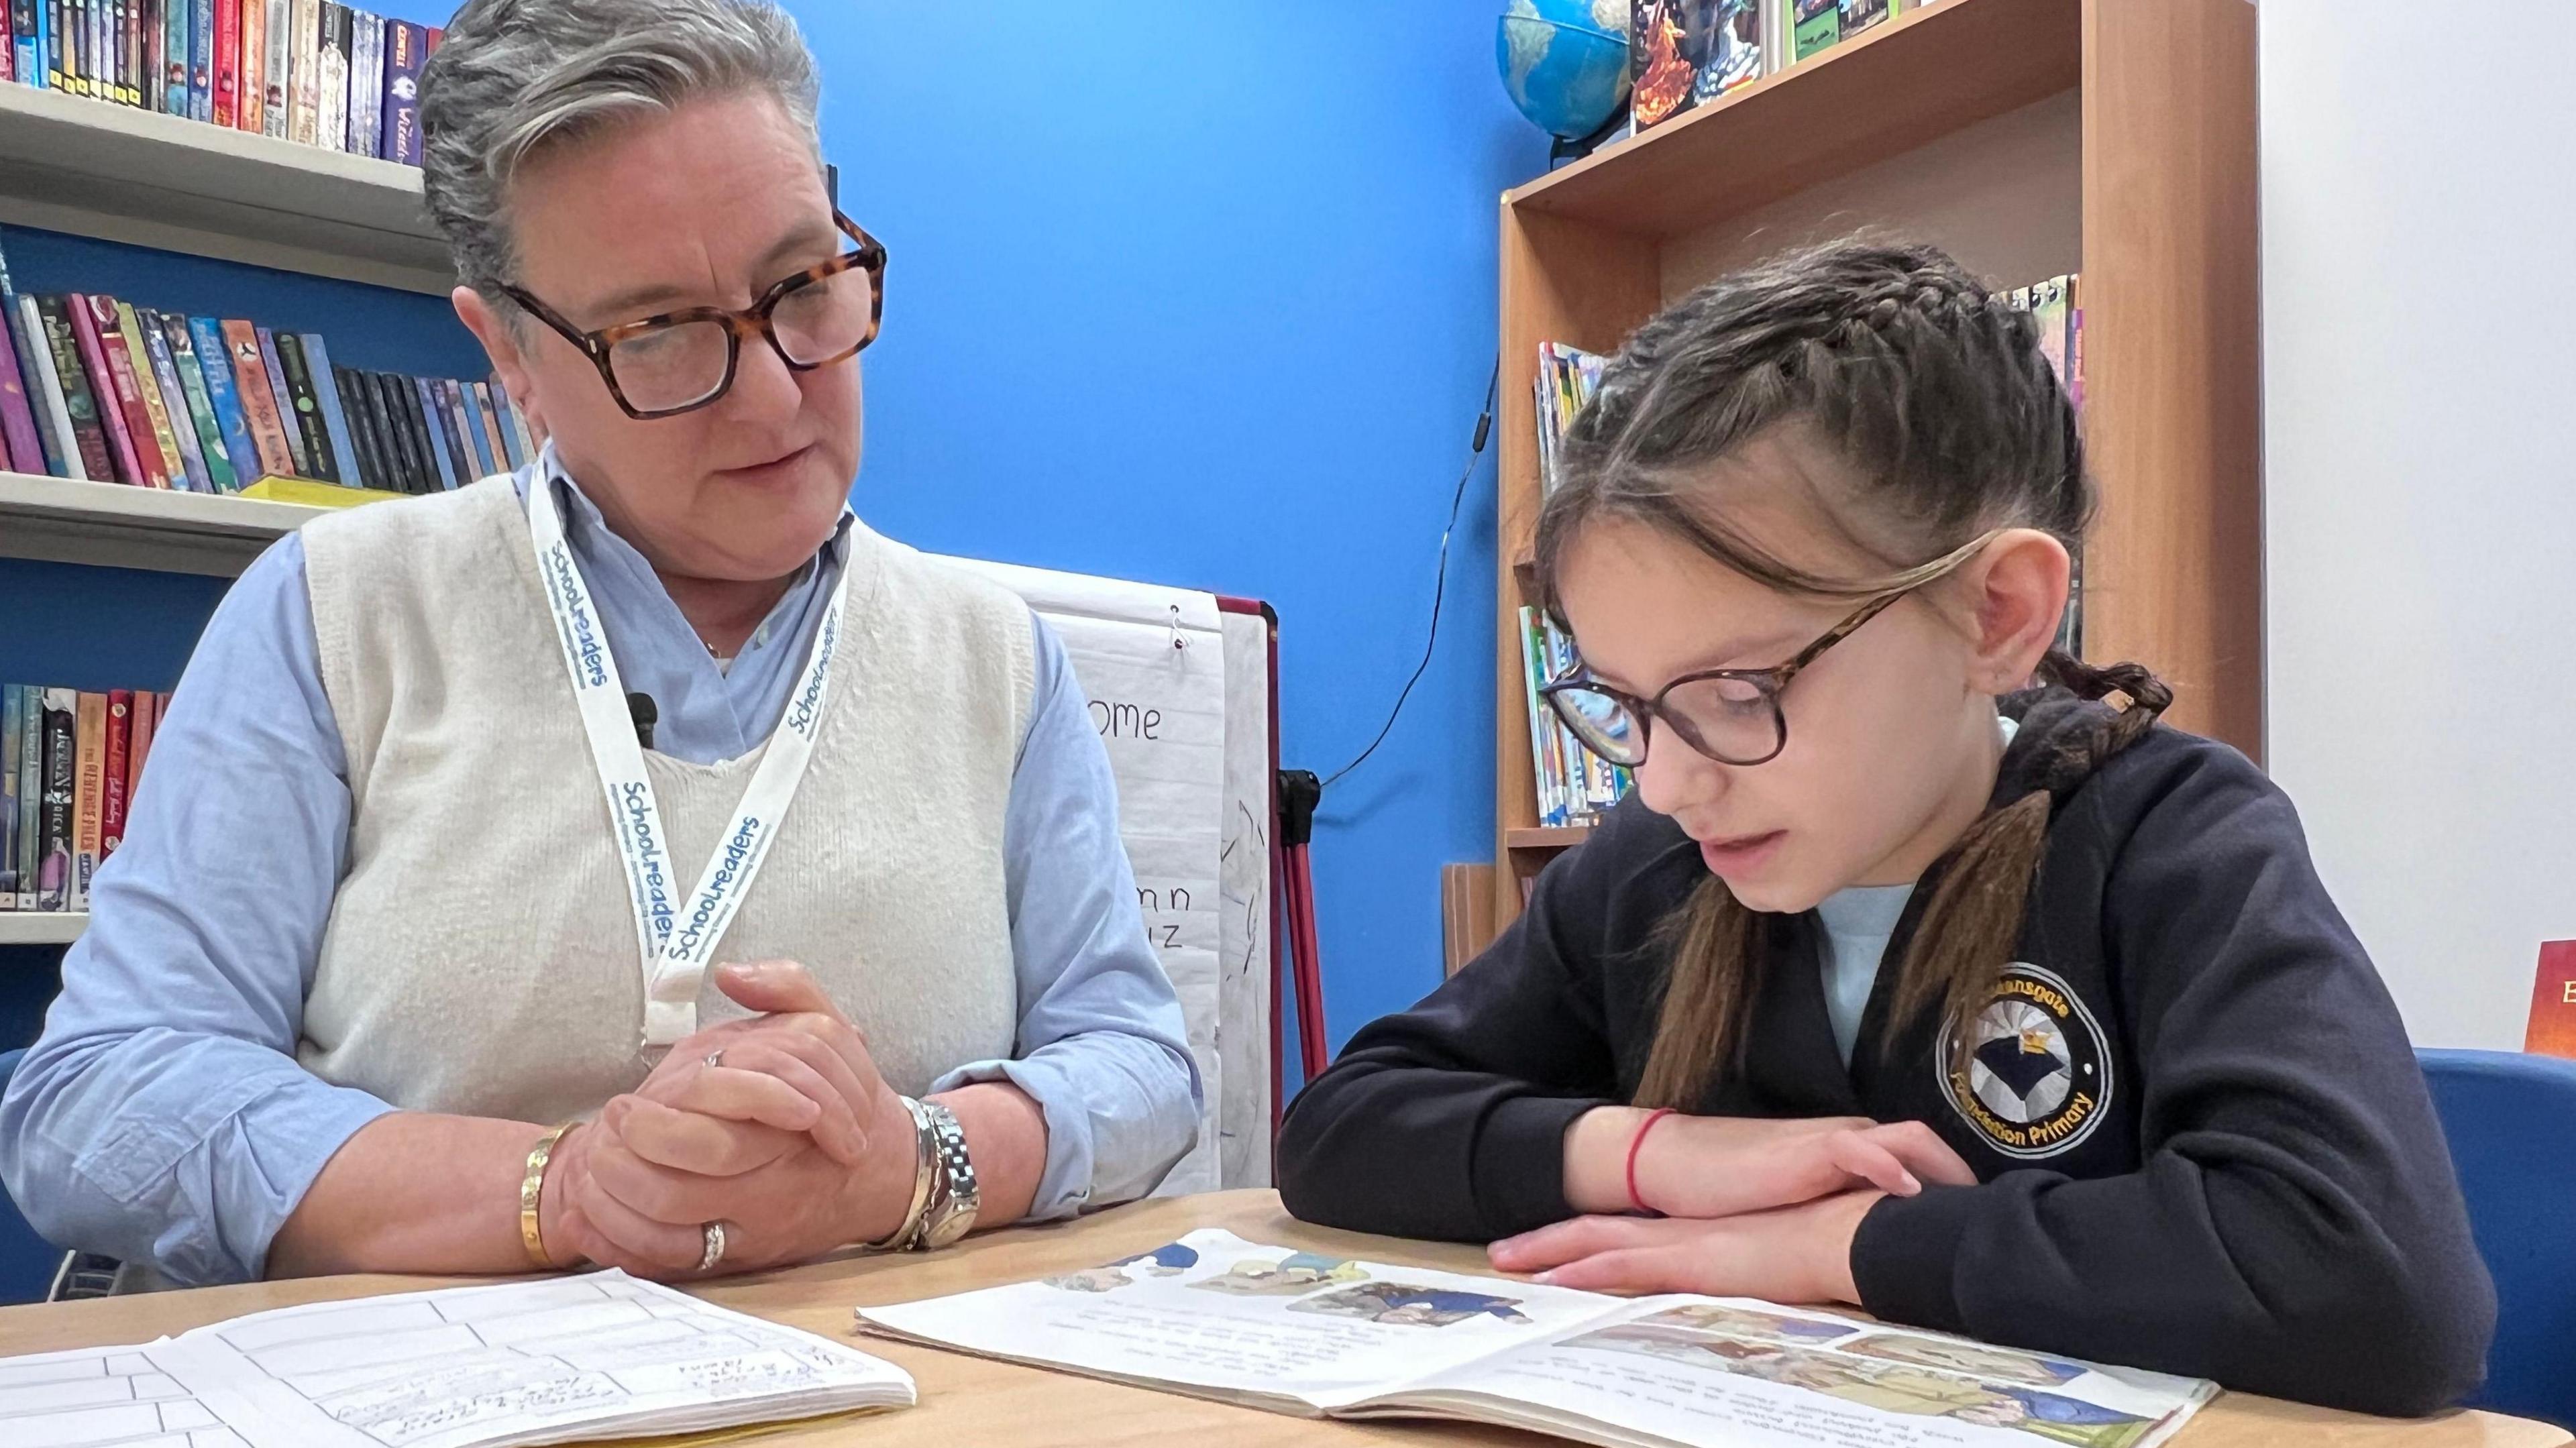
[858,1229,2218,1448]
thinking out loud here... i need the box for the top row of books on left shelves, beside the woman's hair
[0,0,445,165]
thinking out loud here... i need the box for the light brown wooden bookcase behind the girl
[1491,0,2262,930]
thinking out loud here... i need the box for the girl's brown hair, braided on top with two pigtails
[1538,239,2171,1111]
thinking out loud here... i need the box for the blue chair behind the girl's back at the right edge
[2416,1051,2576,1427]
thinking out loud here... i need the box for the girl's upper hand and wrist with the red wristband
[1566,1108,1976,1219]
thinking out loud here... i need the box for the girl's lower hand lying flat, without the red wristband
[1487,1190,1886,1304]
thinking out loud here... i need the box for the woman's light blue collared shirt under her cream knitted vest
[0,471,1203,1283]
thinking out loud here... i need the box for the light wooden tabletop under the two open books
[0,1190,2568,1448]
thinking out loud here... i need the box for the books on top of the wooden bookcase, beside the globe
[1628,0,1935,131]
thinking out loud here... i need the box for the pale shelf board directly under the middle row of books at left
[0,471,330,577]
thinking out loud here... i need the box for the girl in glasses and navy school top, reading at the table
[1280,242,2493,1414]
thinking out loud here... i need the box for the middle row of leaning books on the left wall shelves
[0,270,536,492]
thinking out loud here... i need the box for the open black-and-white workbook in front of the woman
[0,1273,912,1448]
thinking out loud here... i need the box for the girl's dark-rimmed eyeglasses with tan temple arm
[1538,531,2002,768]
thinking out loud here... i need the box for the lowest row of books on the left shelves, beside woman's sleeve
[0,683,170,909]
